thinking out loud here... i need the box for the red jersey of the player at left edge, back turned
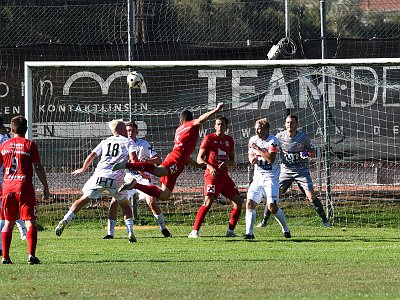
[0,137,40,194]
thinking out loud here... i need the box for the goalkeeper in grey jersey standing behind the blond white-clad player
[257,115,331,227]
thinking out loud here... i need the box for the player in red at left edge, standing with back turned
[0,116,50,264]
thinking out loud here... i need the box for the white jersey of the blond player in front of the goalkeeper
[249,134,280,179]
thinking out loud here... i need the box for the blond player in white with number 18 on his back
[55,120,138,243]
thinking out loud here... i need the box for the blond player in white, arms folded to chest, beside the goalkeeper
[244,118,291,240]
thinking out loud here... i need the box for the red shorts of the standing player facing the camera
[204,174,239,200]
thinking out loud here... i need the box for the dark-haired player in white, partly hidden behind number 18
[104,122,172,239]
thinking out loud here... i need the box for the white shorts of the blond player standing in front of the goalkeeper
[247,176,279,204]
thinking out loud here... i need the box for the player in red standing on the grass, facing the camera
[188,116,243,238]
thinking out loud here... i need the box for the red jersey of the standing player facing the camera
[200,133,235,175]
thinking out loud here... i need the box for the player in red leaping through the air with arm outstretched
[113,103,224,200]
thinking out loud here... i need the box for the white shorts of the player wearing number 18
[82,175,128,201]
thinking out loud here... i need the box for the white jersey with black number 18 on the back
[92,135,136,179]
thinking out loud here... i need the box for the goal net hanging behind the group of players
[25,59,400,227]
